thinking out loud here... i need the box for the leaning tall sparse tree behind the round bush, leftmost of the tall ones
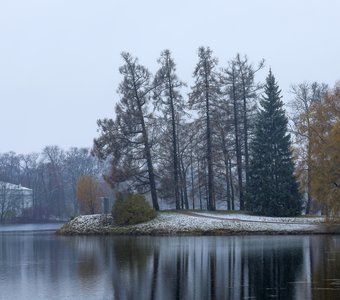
[93,52,159,210]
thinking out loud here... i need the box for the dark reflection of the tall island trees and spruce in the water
[112,236,303,299]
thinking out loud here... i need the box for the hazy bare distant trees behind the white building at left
[0,146,103,220]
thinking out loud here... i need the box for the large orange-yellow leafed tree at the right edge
[311,84,340,219]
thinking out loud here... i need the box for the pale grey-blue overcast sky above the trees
[0,0,340,153]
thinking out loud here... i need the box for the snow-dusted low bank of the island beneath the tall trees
[57,211,340,235]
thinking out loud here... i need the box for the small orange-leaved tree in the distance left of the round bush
[77,176,102,214]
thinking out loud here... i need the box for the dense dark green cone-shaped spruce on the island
[246,71,302,216]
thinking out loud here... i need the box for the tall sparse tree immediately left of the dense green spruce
[221,54,264,210]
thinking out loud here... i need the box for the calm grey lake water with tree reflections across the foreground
[0,224,340,300]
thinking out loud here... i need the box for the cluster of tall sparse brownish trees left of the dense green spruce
[93,47,264,210]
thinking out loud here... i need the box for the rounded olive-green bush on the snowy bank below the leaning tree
[112,193,156,225]
